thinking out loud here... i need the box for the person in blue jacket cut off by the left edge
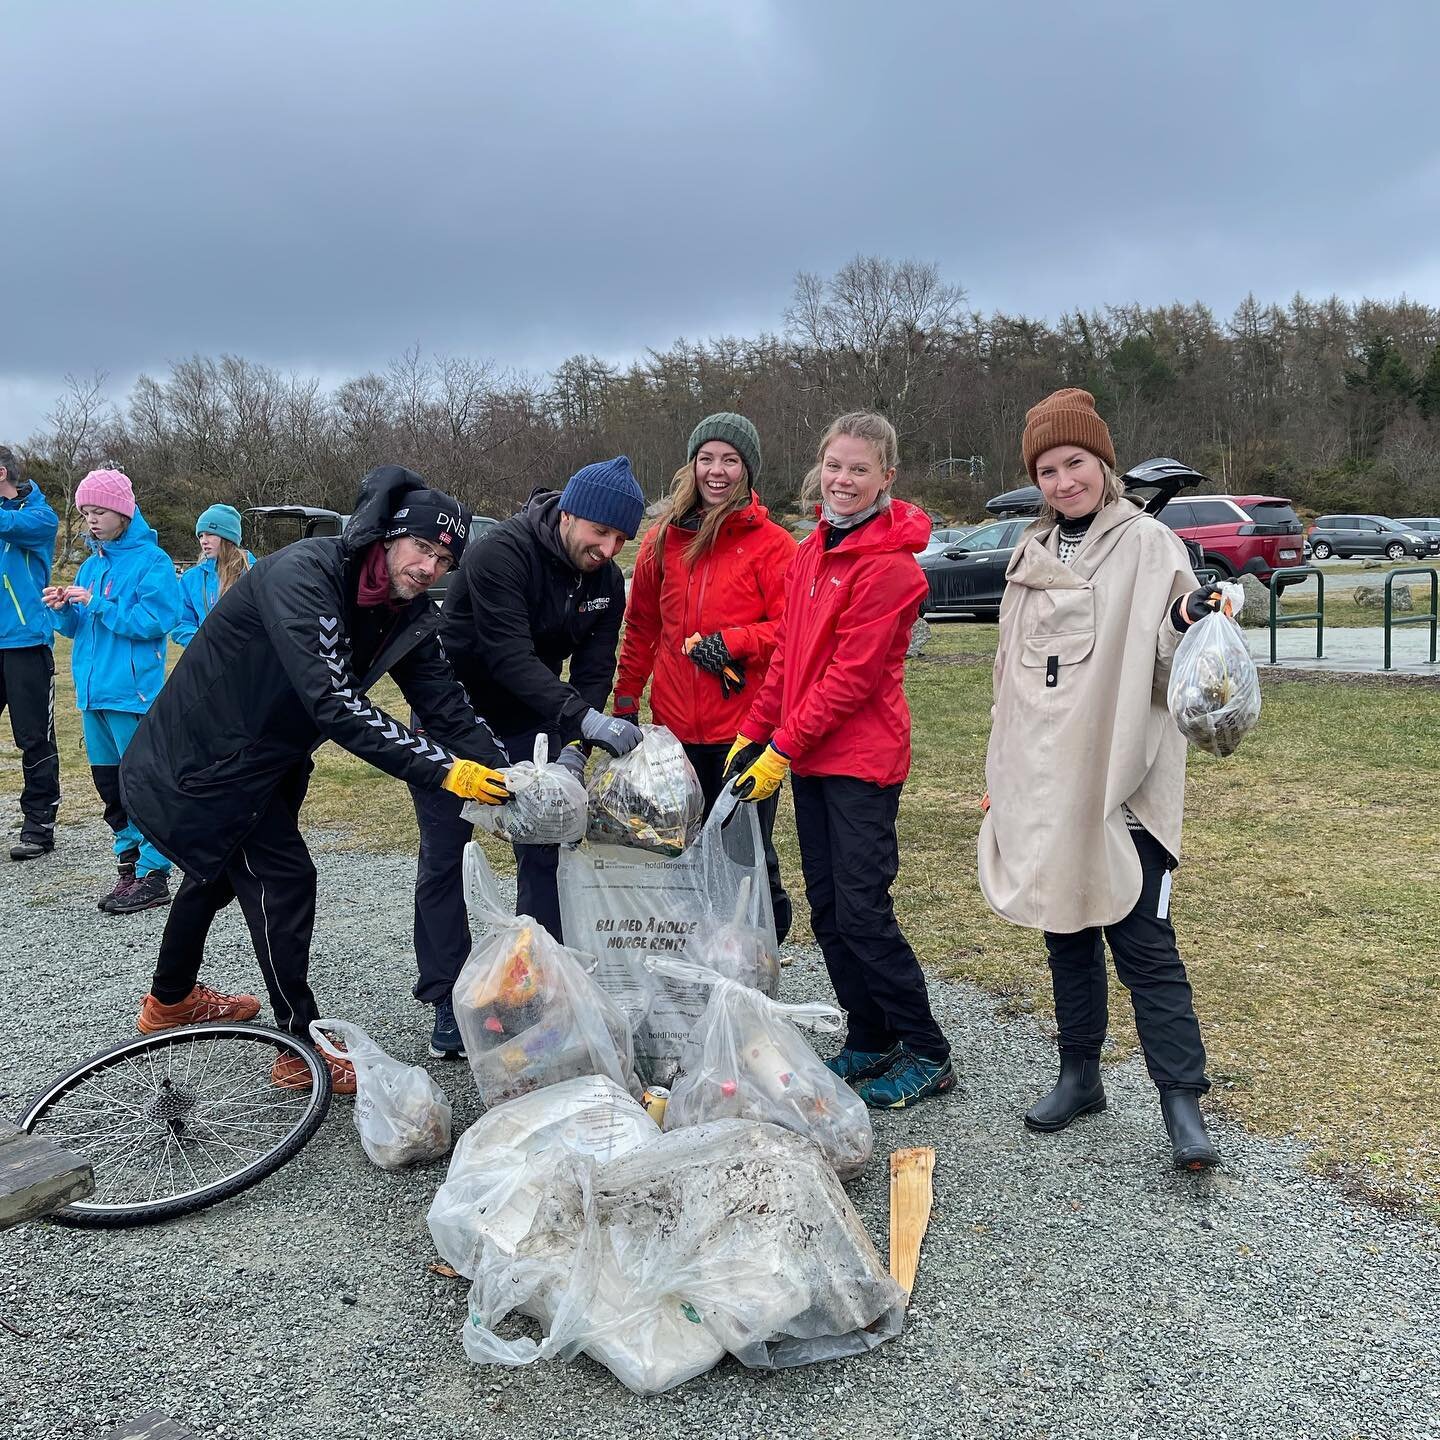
[0,445,60,860]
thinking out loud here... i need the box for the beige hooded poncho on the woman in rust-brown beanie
[979,500,1198,935]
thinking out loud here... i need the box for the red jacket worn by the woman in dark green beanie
[615,500,796,744]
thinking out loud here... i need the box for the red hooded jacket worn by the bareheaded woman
[740,500,930,785]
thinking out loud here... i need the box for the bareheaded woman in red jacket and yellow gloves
[727,412,955,1110]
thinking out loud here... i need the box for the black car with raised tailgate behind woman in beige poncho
[917,459,1218,615]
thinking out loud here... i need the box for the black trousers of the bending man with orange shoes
[150,760,320,1037]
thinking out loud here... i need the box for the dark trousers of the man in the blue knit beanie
[410,730,564,1005]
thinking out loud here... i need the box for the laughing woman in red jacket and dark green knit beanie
[615,413,795,940]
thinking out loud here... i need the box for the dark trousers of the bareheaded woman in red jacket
[793,775,950,1060]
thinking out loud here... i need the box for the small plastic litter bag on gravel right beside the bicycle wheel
[310,1020,451,1169]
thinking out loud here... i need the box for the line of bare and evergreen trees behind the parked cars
[26,256,1440,554]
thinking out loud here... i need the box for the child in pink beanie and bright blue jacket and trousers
[45,469,180,914]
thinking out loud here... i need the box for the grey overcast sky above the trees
[0,0,1440,441]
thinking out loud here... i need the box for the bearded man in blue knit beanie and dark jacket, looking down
[410,455,645,1058]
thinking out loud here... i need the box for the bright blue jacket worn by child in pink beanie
[55,510,180,714]
